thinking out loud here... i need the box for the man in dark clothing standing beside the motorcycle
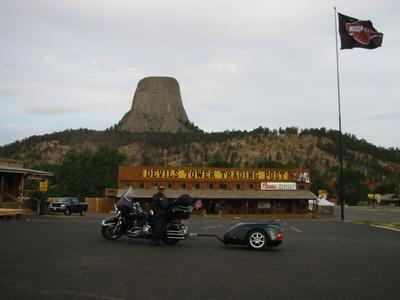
[151,185,168,246]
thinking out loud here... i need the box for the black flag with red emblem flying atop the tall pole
[338,13,383,49]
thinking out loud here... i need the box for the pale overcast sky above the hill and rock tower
[0,0,400,148]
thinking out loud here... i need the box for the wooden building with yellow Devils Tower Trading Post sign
[118,166,317,214]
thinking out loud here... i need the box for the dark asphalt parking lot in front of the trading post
[0,207,400,299]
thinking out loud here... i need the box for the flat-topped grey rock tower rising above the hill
[118,77,190,132]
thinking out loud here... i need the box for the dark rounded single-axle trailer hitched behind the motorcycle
[223,220,283,250]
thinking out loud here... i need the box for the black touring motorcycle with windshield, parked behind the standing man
[101,187,193,245]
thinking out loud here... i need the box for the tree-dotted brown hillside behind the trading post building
[0,127,400,193]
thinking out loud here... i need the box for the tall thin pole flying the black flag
[334,7,344,221]
